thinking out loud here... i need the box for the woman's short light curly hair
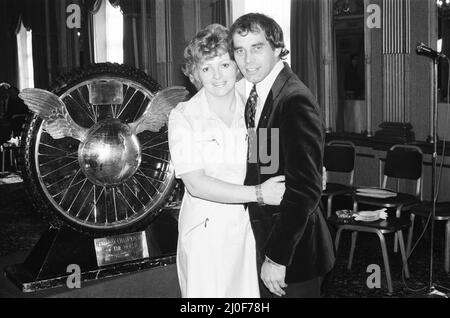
[182,23,229,89]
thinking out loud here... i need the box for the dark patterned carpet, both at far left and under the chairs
[0,176,450,298]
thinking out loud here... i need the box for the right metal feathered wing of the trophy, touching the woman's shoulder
[130,86,189,134]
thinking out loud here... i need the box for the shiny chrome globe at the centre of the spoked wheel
[78,118,142,187]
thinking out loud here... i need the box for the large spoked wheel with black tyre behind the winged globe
[22,63,175,236]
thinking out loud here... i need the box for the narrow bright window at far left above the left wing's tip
[17,22,34,90]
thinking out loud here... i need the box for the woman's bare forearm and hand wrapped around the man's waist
[181,170,284,205]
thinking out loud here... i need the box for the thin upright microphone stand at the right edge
[426,56,449,298]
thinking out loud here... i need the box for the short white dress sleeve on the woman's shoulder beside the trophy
[169,109,204,178]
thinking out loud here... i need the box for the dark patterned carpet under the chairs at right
[324,229,450,298]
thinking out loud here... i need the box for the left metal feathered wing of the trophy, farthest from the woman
[19,88,88,141]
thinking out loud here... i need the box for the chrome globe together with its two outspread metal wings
[19,86,187,186]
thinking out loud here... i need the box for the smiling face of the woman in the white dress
[196,53,238,97]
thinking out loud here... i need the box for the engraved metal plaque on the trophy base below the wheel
[94,231,149,267]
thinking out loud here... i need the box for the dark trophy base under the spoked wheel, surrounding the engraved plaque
[5,209,178,293]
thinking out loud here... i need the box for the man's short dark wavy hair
[228,13,289,59]
